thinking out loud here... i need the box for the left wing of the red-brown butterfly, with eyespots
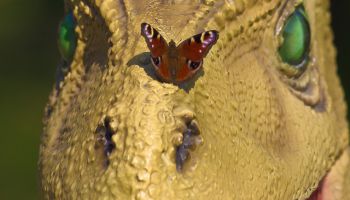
[141,23,171,81]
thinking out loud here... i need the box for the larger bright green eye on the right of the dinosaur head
[279,6,310,68]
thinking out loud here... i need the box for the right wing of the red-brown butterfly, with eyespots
[175,30,219,82]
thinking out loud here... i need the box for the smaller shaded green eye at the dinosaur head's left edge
[58,12,77,61]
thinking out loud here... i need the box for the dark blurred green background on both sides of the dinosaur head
[0,0,350,199]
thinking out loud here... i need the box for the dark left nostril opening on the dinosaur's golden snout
[95,117,116,168]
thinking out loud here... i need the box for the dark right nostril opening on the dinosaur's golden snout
[175,121,202,172]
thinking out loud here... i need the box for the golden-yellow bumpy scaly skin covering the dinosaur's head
[39,0,350,200]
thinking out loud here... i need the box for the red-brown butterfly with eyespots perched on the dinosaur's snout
[141,23,219,84]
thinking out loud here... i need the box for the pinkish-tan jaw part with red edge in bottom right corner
[308,148,350,200]
